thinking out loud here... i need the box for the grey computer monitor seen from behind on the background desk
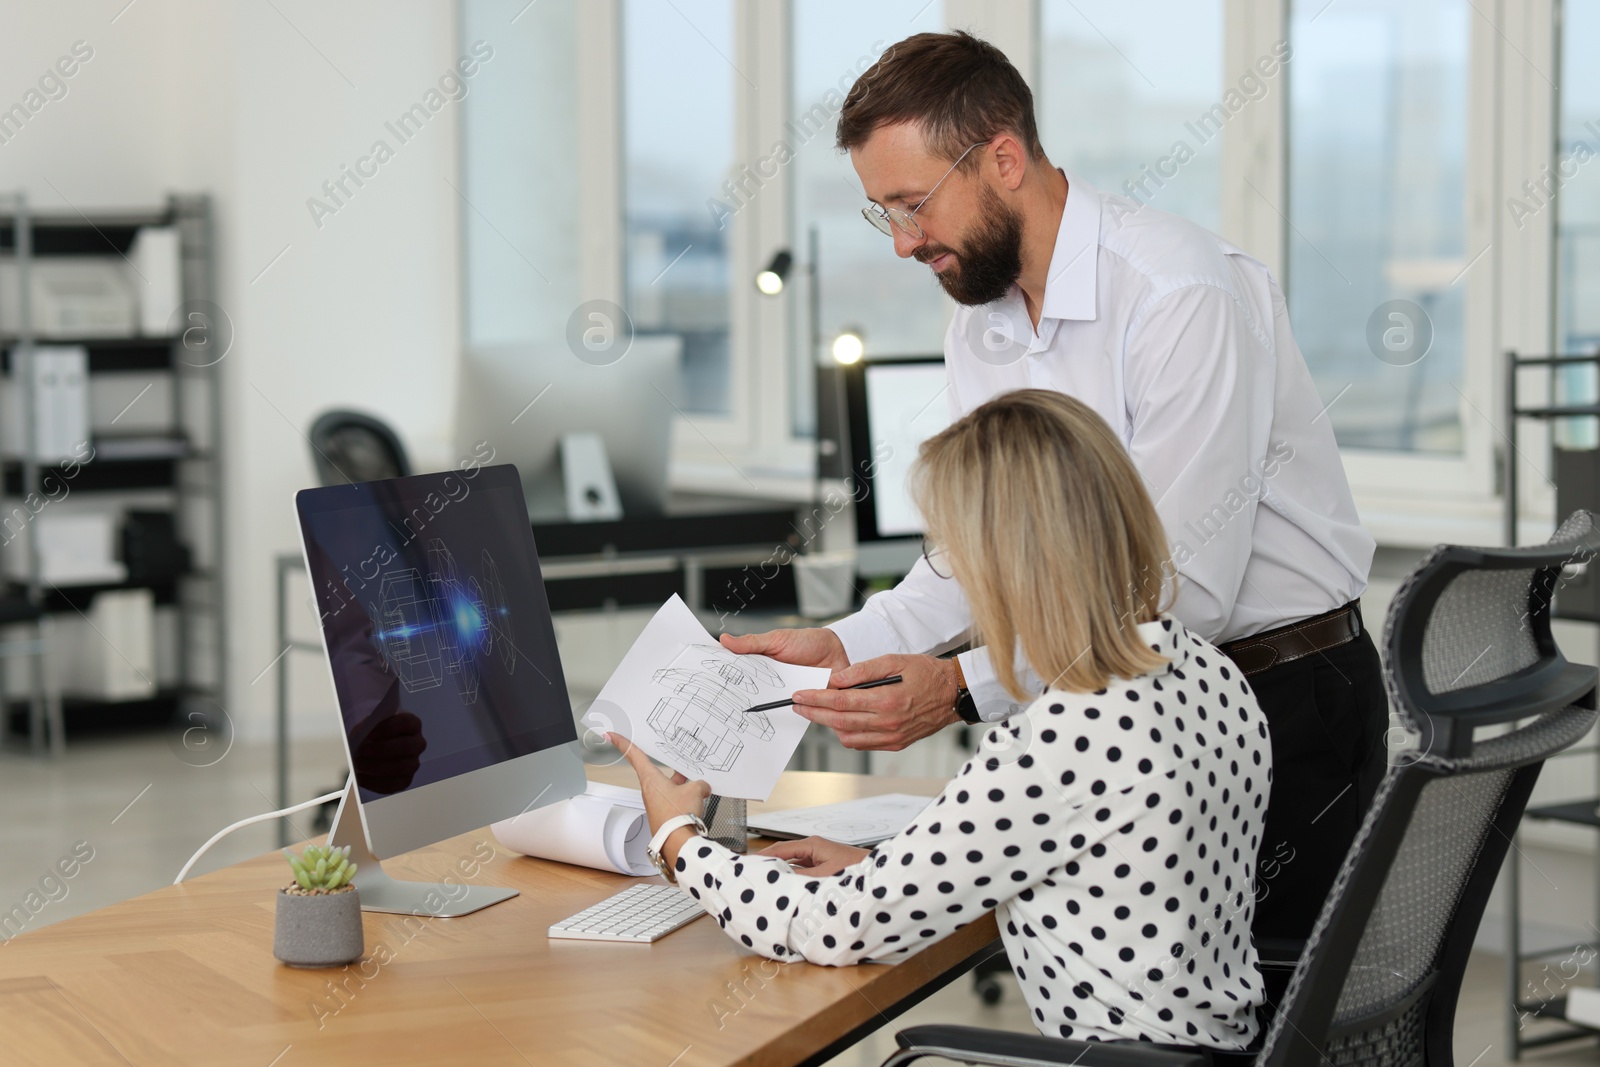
[458,334,683,522]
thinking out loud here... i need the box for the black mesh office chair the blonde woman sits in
[885,512,1600,1067]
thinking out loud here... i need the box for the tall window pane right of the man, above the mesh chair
[1262,0,1480,453]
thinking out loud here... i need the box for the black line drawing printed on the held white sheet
[646,645,784,773]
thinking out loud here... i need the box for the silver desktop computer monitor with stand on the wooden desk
[294,464,586,915]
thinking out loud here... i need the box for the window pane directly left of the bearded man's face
[790,0,954,434]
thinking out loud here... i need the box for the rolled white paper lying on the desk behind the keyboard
[490,782,656,875]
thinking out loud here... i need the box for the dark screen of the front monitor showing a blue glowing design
[296,464,578,801]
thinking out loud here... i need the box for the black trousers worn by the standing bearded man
[1248,630,1389,942]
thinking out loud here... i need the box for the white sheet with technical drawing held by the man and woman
[584,595,832,800]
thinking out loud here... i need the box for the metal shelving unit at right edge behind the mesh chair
[1504,352,1600,1061]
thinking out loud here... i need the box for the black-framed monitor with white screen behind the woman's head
[845,355,950,576]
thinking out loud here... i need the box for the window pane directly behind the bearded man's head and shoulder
[1037,0,1222,230]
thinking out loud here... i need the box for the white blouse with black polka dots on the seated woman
[677,619,1272,1048]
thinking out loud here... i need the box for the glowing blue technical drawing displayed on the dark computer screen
[373,537,517,704]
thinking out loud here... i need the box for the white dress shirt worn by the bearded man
[832,174,1376,720]
